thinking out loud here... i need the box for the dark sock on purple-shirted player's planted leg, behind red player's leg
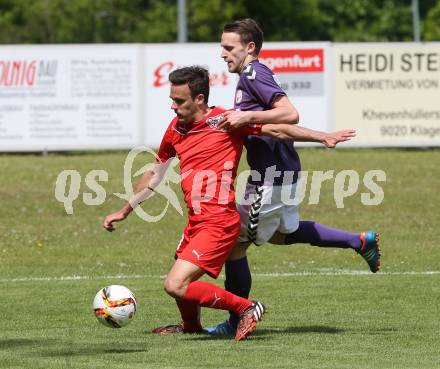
[225,256,252,327]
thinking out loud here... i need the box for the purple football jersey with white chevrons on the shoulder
[234,60,301,185]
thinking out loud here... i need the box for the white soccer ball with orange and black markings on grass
[93,285,137,328]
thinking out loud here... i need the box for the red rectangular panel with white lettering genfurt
[258,49,324,73]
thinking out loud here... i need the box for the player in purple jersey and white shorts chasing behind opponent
[206,18,380,335]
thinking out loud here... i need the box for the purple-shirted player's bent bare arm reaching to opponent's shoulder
[219,96,299,129]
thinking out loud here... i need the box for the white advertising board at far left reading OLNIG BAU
[0,45,141,151]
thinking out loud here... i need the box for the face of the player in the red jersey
[170,84,199,124]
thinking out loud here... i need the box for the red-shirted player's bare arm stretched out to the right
[261,124,356,148]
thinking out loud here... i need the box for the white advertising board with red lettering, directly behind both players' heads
[144,42,330,147]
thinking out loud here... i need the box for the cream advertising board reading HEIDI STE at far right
[333,43,440,147]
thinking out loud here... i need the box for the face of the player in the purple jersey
[220,32,251,73]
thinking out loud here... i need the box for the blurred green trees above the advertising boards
[0,0,440,44]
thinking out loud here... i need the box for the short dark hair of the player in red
[168,65,209,104]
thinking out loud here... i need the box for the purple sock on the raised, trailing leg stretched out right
[286,221,361,249]
